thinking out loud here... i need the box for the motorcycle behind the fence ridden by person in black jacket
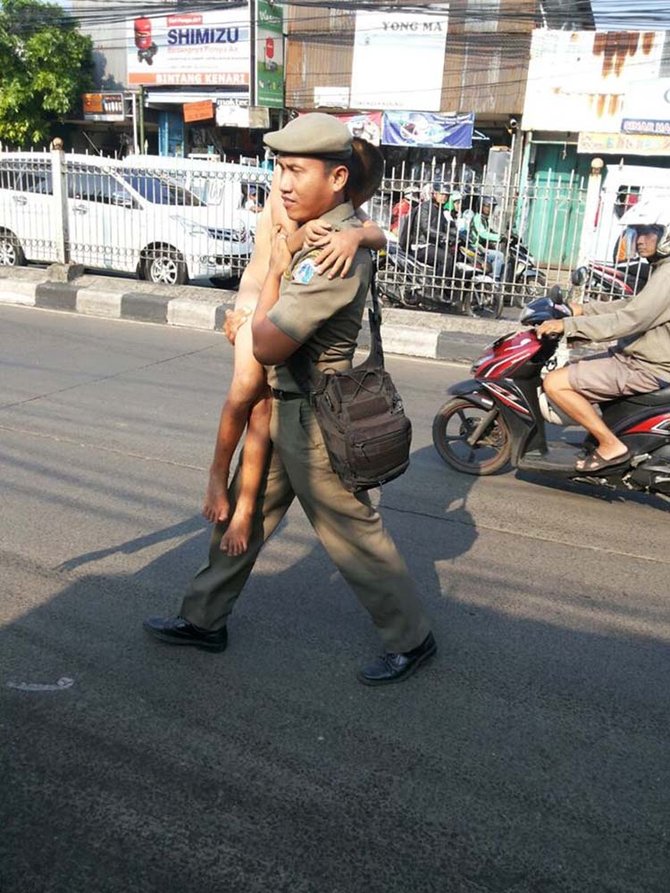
[377,238,503,319]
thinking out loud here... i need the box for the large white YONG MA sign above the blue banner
[350,12,447,111]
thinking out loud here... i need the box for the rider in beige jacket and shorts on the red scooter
[537,203,670,474]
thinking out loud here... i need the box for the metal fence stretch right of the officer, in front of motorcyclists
[370,162,670,316]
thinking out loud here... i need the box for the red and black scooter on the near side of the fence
[433,287,670,495]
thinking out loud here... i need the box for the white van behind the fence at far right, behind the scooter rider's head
[593,164,670,262]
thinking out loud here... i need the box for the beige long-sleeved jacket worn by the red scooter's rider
[565,257,670,381]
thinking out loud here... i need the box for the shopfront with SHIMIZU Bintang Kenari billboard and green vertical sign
[126,0,284,161]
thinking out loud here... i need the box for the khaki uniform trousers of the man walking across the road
[180,398,430,652]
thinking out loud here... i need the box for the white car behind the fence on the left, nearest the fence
[0,152,253,284]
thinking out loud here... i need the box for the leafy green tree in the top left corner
[0,0,93,147]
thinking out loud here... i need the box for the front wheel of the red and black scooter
[433,397,512,476]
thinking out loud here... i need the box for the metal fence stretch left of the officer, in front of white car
[0,151,271,284]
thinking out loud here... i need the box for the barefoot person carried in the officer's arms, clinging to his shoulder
[203,139,386,555]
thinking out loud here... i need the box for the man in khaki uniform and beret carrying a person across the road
[144,113,436,685]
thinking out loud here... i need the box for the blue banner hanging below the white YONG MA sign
[382,112,475,149]
